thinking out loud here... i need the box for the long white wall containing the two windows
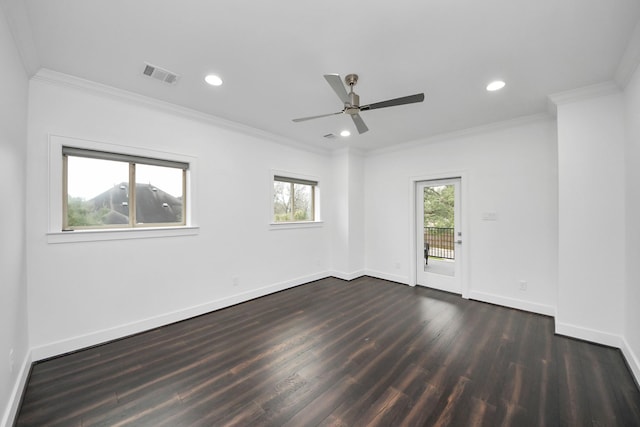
[27,72,332,359]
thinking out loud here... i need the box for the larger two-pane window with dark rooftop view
[62,146,189,230]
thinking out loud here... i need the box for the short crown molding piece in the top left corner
[0,0,40,77]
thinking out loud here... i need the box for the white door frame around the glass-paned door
[409,170,471,299]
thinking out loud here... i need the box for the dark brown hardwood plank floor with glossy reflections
[16,277,640,427]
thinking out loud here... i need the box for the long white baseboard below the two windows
[31,272,332,361]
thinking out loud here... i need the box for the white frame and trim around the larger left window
[47,135,198,243]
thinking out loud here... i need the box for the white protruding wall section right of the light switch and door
[556,93,625,346]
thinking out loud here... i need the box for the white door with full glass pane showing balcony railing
[416,178,464,294]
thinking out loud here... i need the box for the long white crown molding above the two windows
[31,68,331,156]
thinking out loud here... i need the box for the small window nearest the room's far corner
[273,175,318,223]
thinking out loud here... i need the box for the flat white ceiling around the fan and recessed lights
[9,0,640,150]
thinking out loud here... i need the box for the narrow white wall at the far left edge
[0,8,29,425]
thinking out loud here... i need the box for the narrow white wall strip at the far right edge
[623,71,640,381]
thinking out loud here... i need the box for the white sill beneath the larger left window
[47,226,200,243]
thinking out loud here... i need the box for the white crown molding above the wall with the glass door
[365,113,553,157]
